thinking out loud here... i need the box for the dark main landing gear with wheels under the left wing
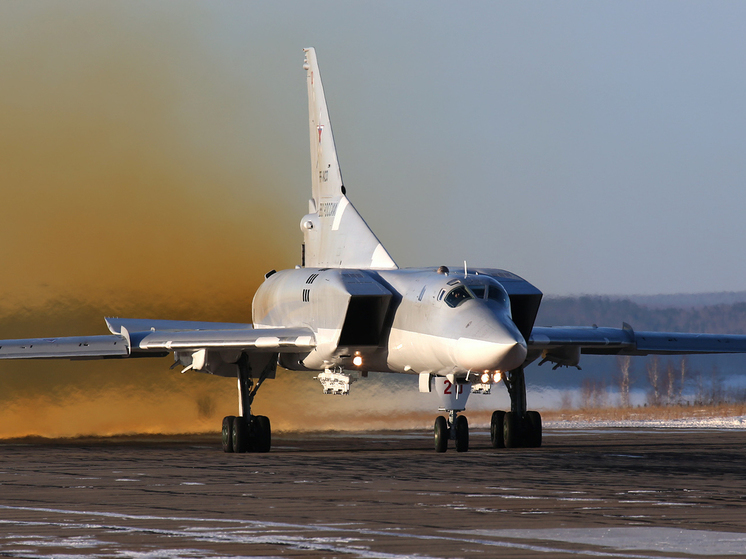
[222,353,277,452]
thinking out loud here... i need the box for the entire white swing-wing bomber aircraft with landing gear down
[0,48,746,452]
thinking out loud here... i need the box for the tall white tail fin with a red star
[301,48,397,269]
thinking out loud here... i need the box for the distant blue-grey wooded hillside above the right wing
[536,295,746,334]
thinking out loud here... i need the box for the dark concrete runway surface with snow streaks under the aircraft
[0,429,746,559]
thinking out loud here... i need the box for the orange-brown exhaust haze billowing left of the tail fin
[0,4,305,437]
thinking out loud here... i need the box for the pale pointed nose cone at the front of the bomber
[456,329,527,371]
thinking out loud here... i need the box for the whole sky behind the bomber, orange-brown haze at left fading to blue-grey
[0,0,746,437]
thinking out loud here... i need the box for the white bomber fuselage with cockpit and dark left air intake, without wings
[253,268,526,376]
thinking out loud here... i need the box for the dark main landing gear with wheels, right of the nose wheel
[490,367,541,448]
